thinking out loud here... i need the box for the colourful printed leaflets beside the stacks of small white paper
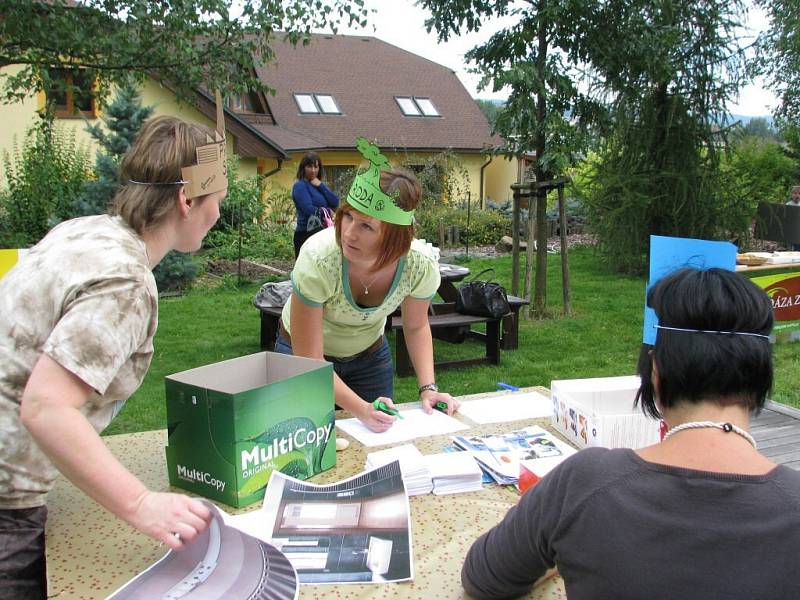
[453,425,575,485]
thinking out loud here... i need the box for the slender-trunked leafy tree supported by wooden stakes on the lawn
[420,0,601,316]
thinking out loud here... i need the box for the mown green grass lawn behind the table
[105,247,800,435]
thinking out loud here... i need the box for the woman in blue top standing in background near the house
[292,152,339,258]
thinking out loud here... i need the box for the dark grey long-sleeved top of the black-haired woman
[461,448,800,600]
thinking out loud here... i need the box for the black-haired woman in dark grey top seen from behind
[462,269,800,600]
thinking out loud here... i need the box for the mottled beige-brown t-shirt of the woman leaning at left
[0,215,158,508]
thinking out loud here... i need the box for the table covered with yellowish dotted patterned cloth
[47,387,566,600]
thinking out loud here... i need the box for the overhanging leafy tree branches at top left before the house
[0,0,367,101]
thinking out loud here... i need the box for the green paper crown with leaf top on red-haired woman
[347,137,414,225]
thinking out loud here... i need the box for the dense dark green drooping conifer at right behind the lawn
[590,0,746,272]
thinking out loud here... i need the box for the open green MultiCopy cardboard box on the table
[166,352,336,507]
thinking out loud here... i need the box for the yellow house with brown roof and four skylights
[0,34,520,210]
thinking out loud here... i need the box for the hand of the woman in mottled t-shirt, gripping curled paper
[125,490,211,550]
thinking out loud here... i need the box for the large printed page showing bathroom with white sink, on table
[259,460,413,584]
